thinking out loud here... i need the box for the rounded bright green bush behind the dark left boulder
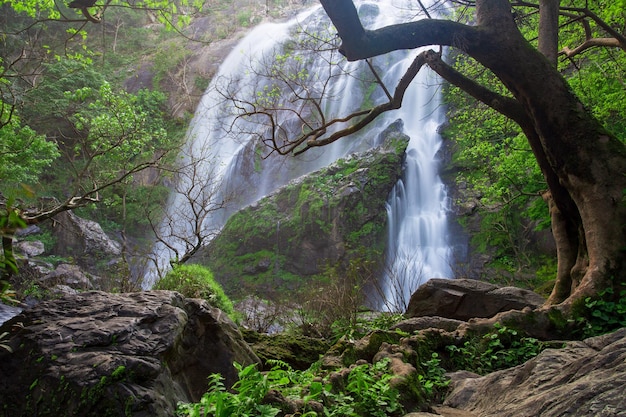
[154,265,234,315]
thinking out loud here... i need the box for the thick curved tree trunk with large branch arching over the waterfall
[320,0,626,303]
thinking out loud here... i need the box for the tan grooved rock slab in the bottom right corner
[445,329,626,417]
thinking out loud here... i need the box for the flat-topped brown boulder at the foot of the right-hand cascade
[406,278,545,321]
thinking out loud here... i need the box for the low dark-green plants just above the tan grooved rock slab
[446,323,546,375]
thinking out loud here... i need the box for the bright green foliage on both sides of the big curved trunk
[443,1,626,290]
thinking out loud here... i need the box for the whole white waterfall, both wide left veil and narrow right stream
[143,0,450,302]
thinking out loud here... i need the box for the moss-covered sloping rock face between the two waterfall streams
[192,122,409,294]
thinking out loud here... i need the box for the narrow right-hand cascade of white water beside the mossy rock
[379,63,452,312]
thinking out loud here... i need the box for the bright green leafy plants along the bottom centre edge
[177,359,403,417]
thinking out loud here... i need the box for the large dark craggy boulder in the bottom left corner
[0,291,259,417]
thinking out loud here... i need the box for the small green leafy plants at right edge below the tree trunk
[572,283,626,338]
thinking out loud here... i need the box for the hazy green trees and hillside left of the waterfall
[0,0,302,286]
